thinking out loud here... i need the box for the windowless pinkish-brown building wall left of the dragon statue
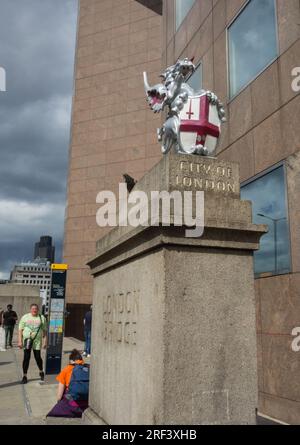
[63,0,162,338]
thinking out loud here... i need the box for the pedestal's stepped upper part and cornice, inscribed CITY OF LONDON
[89,154,266,273]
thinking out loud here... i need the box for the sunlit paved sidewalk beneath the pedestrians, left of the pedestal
[0,338,87,425]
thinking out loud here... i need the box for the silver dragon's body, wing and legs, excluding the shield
[144,58,226,156]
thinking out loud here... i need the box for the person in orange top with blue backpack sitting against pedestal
[47,349,89,417]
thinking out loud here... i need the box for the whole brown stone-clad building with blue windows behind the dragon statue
[64,0,300,423]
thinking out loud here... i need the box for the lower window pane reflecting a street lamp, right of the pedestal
[241,166,290,275]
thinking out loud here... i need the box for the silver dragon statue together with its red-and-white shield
[144,58,226,156]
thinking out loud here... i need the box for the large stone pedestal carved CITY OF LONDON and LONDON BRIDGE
[87,155,266,425]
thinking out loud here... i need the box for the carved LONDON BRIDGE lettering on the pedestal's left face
[102,290,140,345]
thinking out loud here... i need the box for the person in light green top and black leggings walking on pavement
[18,304,47,384]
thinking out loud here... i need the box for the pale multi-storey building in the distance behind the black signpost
[10,259,51,314]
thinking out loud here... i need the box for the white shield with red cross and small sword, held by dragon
[178,94,221,156]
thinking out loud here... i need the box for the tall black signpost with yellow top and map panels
[45,264,68,375]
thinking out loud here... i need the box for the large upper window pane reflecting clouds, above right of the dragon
[228,0,277,97]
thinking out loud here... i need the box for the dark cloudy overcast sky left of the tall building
[0,0,77,278]
